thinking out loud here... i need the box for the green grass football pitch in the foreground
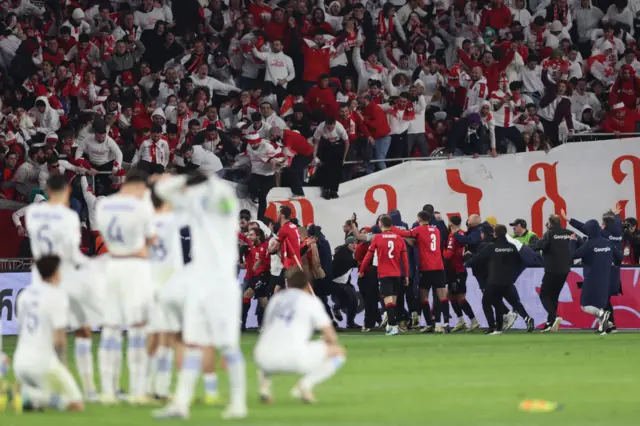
[0,332,640,426]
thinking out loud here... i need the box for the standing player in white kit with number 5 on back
[25,175,104,401]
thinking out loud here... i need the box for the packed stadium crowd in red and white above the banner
[0,0,640,223]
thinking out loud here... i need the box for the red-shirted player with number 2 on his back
[358,215,409,336]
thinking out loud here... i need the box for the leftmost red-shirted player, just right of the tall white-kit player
[242,226,272,330]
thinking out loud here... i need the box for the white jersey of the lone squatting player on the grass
[256,288,331,351]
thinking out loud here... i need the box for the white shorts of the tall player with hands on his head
[182,278,242,348]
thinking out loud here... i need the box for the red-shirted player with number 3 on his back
[393,211,451,333]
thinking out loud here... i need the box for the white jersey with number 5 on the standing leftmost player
[25,203,86,264]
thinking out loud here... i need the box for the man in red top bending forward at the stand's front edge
[271,127,313,198]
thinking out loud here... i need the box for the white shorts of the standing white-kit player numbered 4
[104,257,154,327]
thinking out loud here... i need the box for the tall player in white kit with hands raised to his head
[154,172,247,418]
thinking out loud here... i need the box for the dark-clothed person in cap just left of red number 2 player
[331,237,360,328]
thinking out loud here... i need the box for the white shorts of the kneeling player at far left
[14,359,82,405]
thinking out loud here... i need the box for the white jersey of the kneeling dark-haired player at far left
[14,282,69,370]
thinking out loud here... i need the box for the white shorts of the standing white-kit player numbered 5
[32,260,106,330]
